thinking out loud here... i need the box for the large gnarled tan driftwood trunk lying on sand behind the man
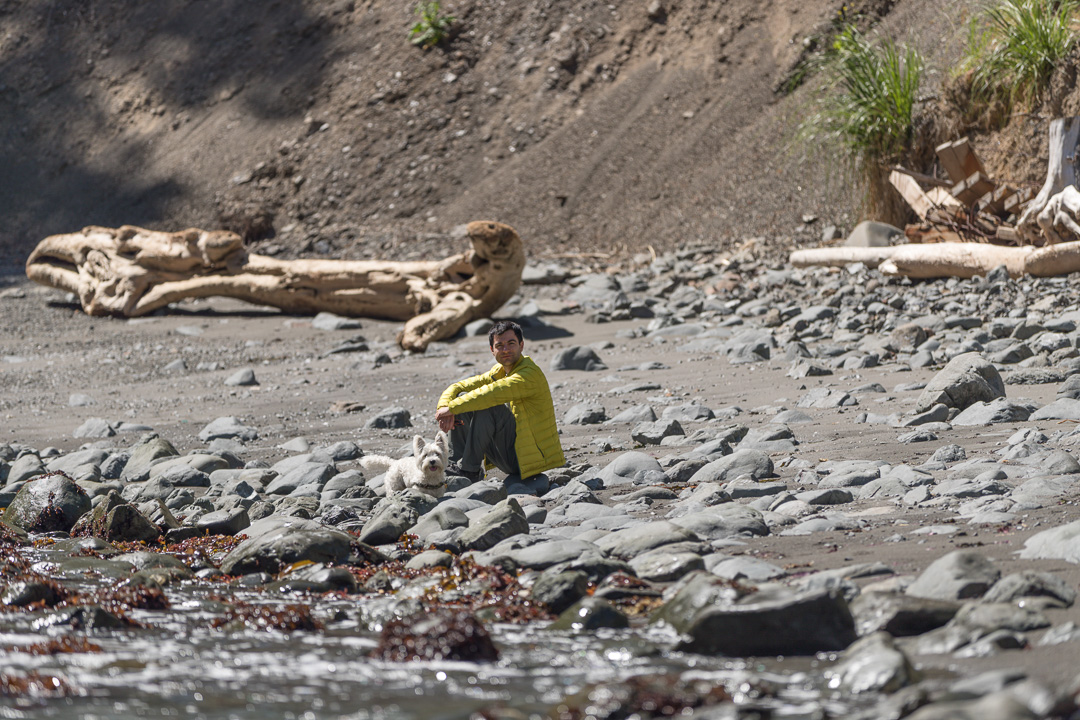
[26,220,525,351]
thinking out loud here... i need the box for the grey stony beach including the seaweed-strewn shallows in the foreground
[0,247,1080,720]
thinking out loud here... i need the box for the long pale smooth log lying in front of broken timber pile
[791,241,1080,279]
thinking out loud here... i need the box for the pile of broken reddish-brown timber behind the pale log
[889,137,1035,245]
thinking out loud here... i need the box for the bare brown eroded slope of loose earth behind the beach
[0,0,989,269]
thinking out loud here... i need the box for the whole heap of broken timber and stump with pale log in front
[791,118,1080,277]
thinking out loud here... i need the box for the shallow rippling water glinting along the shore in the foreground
[0,588,868,720]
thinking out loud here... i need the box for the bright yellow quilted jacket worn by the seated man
[438,355,566,479]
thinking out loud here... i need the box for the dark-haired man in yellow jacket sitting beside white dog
[435,321,566,481]
